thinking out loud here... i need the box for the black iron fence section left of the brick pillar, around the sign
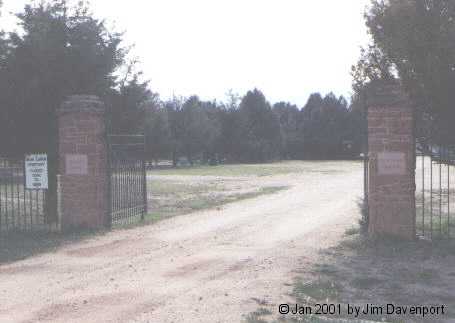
[0,158,56,233]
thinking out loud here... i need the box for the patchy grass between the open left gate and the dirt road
[142,161,352,221]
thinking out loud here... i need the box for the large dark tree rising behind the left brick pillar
[0,0,125,154]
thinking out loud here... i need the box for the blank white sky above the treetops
[0,0,369,106]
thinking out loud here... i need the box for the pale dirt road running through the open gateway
[0,162,362,323]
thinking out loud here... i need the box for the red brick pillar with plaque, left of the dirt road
[58,95,108,230]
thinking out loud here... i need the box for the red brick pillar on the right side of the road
[368,82,416,239]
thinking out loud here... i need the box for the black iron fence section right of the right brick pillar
[416,143,455,240]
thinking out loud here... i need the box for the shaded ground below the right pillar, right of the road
[246,229,455,323]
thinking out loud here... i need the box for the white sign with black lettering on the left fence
[25,154,49,190]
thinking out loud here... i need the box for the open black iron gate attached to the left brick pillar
[108,135,148,226]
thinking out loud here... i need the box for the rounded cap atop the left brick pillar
[58,95,106,114]
